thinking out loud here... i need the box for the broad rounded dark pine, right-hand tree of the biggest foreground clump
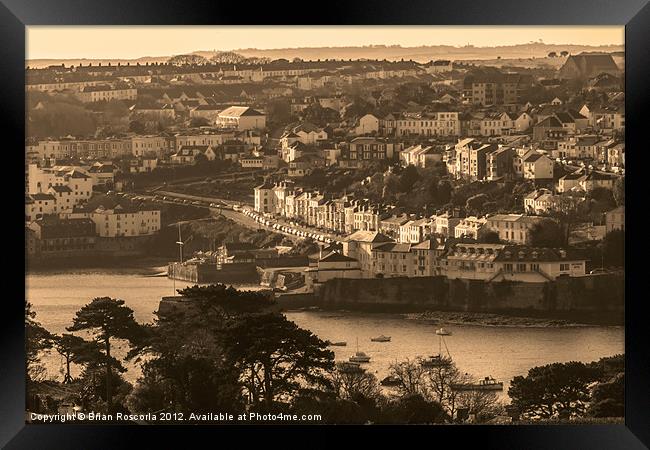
[224,313,334,410]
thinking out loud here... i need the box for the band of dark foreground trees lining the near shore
[25,285,623,424]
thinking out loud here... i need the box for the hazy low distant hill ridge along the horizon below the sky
[25,42,624,68]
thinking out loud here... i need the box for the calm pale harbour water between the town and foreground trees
[26,269,624,393]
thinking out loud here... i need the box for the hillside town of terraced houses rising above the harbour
[25,53,625,290]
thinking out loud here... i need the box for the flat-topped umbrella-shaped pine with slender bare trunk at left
[67,297,141,413]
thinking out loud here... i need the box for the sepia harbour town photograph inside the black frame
[24,25,624,426]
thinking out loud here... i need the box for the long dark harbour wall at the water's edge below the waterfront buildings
[313,274,625,323]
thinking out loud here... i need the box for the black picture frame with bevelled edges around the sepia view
[0,0,650,449]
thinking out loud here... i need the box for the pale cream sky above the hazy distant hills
[26,26,624,59]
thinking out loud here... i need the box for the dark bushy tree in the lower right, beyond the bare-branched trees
[508,361,600,419]
